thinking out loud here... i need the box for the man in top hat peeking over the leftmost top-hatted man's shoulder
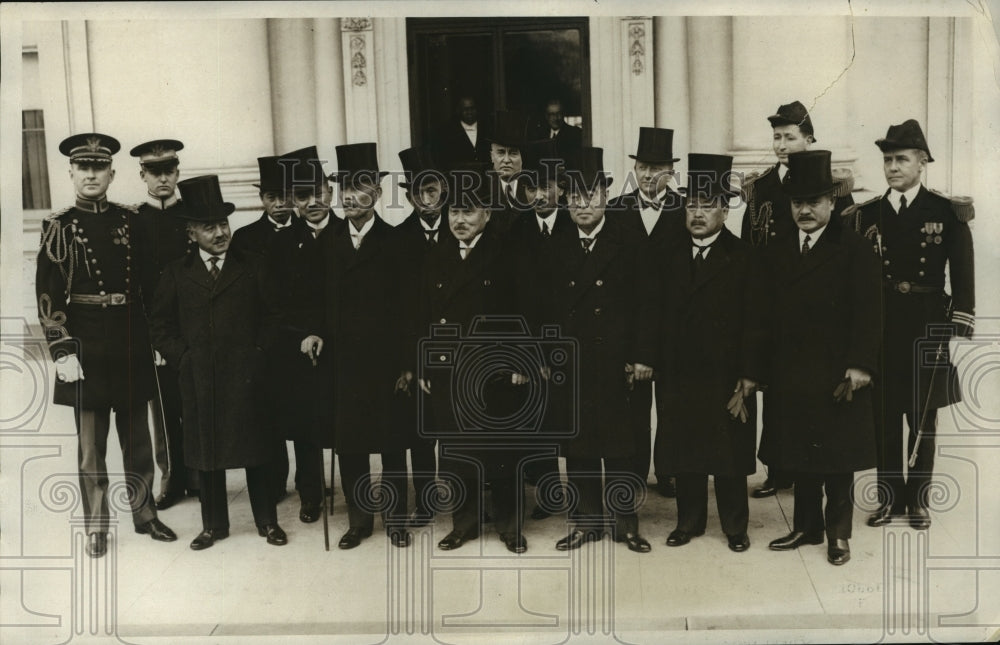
[233,156,303,255]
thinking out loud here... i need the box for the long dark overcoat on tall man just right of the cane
[321,214,402,454]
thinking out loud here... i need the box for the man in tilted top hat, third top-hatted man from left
[264,146,343,523]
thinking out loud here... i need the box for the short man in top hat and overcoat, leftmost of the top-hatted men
[151,175,288,551]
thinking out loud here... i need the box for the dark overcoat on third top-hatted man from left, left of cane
[264,216,344,448]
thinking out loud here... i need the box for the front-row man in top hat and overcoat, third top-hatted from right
[546,147,653,553]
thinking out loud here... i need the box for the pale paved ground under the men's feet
[0,348,1000,644]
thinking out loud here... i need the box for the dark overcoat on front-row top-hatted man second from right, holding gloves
[643,228,767,476]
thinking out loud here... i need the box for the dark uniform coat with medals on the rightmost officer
[848,186,976,418]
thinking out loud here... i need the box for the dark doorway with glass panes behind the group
[406,18,591,146]
